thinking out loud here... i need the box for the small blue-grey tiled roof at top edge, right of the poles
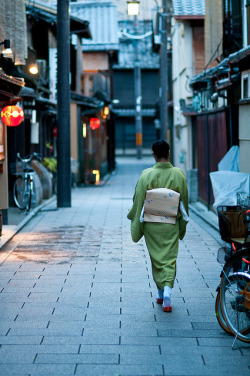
[172,0,205,16]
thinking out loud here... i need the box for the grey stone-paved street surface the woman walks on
[0,158,250,376]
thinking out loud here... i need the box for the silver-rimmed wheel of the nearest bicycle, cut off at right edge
[220,249,250,343]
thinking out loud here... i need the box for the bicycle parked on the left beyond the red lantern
[13,153,41,211]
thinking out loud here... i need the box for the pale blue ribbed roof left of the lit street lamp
[70,1,119,51]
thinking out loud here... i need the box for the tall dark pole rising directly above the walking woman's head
[159,0,168,141]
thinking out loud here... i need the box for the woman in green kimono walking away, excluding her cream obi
[127,140,188,312]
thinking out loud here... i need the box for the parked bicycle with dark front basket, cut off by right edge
[215,205,250,346]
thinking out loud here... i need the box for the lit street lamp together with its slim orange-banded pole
[127,1,142,159]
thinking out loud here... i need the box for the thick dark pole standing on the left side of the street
[57,0,71,208]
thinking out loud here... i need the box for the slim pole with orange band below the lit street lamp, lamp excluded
[134,16,142,159]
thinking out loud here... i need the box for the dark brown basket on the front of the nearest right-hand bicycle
[217,205,248,243]
